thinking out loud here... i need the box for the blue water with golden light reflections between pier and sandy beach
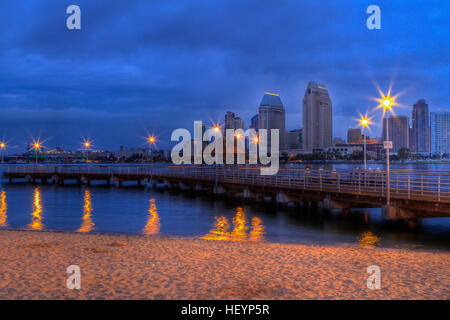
[0,185,450,250]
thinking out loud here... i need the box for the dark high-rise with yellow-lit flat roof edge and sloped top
[258,92,285,151]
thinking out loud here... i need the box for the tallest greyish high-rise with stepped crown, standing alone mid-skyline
[303,82,333,152]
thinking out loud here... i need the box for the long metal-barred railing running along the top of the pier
[3,164,450,203]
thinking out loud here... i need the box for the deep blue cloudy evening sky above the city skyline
[0,0,450,151]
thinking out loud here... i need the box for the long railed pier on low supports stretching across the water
[3,164,450,225]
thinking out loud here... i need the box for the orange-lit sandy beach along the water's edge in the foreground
[0,230,450,299]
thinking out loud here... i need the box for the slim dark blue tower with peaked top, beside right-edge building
[410,99,430,152]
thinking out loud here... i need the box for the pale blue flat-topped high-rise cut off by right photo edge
[430,111,450,154]
